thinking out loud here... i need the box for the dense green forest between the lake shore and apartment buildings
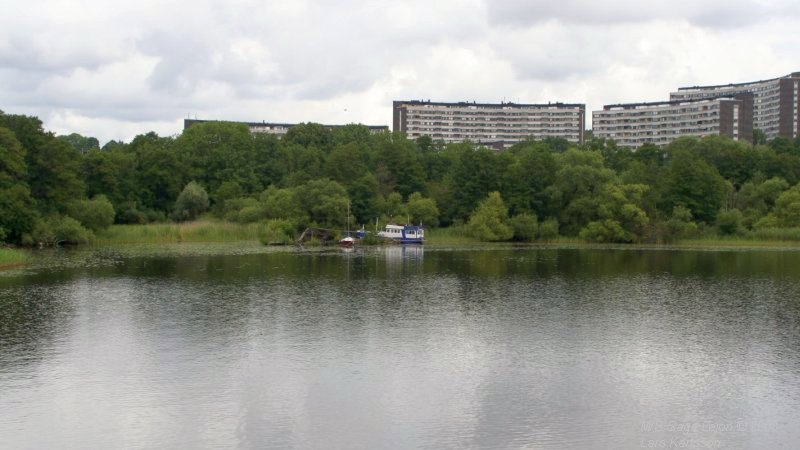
[0,112,800,245]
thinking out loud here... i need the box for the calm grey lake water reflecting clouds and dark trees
[0,244,800,449]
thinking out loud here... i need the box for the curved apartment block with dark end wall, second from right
[592,93,754,149]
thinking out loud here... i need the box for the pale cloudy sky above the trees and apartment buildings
[0,0,800,143]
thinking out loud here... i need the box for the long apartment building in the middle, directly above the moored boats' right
[392,100,586,149]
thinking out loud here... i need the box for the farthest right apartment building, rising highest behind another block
[670,72,800,139]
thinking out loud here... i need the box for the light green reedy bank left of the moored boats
[94,220,264,245]
